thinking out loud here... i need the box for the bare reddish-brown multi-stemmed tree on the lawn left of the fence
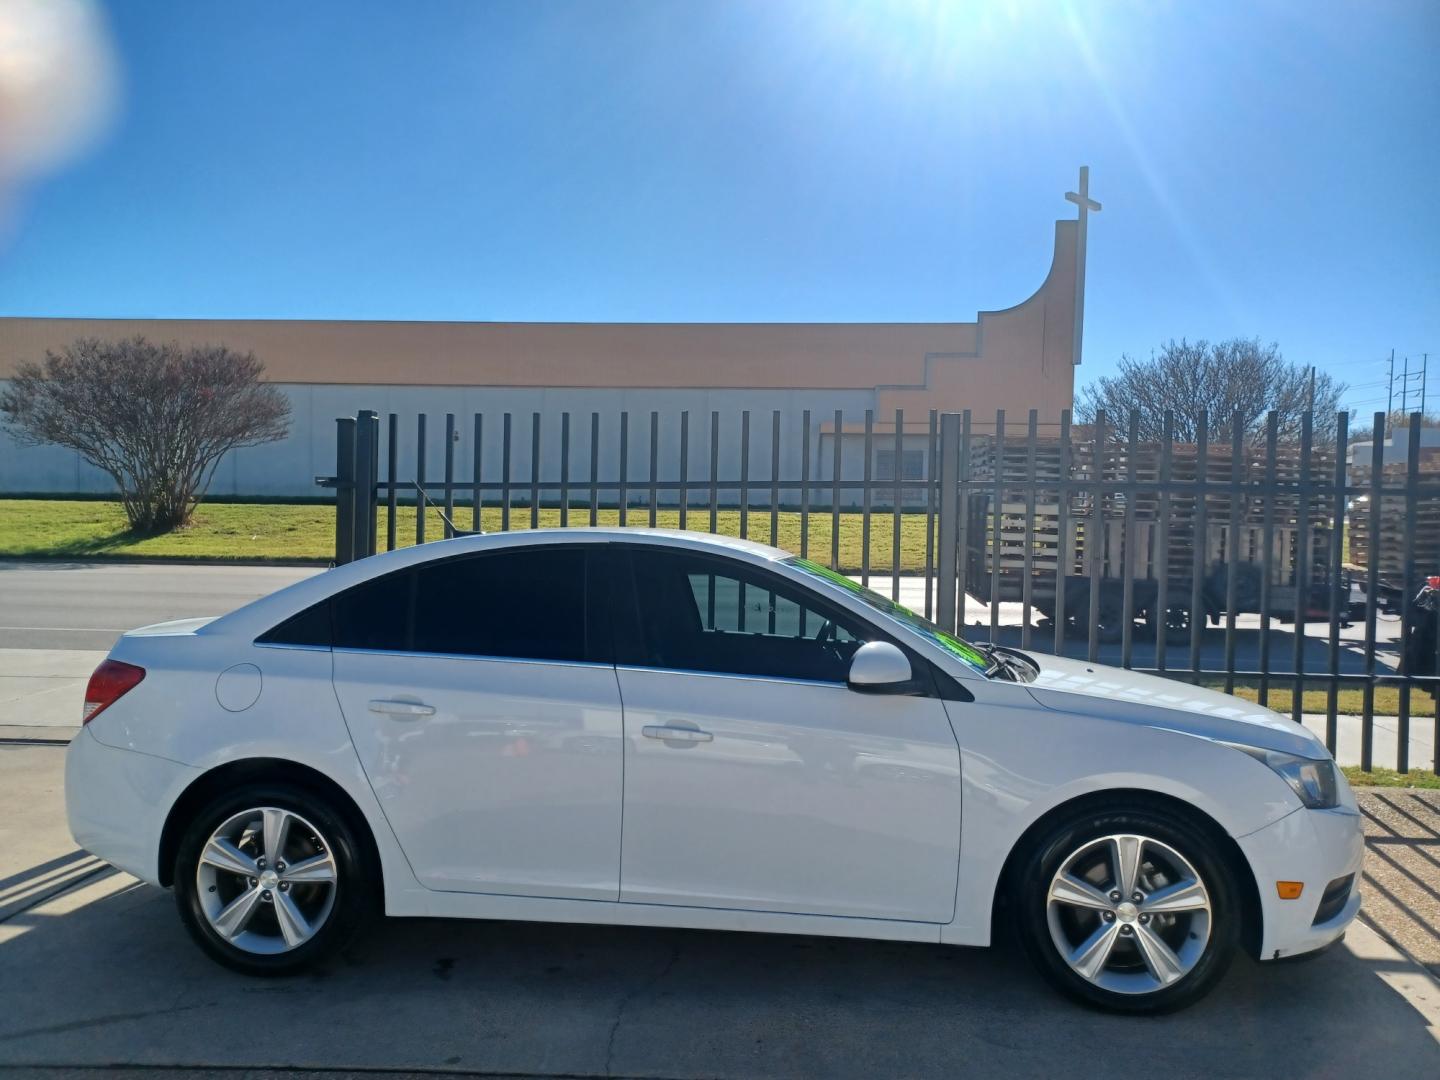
[0,337,289,536]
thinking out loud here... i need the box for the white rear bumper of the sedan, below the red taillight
[65,727,200,884]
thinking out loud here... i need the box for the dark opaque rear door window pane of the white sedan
[413,547,589,661]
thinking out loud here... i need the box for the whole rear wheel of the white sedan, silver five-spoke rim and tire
[174,785,374,975]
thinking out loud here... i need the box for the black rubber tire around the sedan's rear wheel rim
[174,783,380,975]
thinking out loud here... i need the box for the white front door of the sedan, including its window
[616,547,960,923]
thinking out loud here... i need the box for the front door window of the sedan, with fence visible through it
[632,549,873,683]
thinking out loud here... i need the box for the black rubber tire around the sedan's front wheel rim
[1008,806,1240,1014]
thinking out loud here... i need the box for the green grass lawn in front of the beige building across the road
[0,498,924,575]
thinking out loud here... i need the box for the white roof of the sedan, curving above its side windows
[200,526,791,635]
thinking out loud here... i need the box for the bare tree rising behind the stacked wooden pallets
[1076,338,1345,444]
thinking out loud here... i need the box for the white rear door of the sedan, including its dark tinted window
[334,544,622,900]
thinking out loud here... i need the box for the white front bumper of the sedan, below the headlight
[1236,806,1365,960]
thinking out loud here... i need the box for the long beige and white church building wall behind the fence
[0,220,1080,495]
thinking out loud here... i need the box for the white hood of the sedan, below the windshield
[1027,654,1329,757]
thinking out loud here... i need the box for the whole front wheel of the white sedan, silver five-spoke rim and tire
[1011,809,1240,1012]
